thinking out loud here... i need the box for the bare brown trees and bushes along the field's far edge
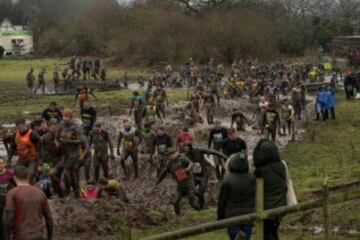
[0,0,360,65]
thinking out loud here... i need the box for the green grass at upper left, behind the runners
[0,59,185,126]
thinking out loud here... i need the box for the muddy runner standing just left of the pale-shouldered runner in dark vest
[89,123,115,182]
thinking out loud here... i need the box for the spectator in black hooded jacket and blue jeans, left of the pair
[217,153,255,240]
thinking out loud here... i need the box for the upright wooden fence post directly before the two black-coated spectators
[255,178,264,240]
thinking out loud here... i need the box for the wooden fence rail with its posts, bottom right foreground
[143,179,360,240]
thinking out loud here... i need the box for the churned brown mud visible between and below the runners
[51,99,311,239]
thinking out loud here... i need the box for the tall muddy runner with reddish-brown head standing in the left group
[57,110,84,198]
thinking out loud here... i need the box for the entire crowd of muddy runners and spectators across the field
[0,57,360,240]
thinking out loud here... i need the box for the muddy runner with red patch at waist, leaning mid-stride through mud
[156,148,201,215]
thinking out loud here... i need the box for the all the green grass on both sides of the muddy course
[0,59,360,240]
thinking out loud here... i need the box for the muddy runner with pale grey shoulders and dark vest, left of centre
[117,120,139,180]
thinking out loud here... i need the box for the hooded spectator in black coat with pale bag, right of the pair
[253,139,287,240]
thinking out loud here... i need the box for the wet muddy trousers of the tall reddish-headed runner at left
[64,158,80,198]
